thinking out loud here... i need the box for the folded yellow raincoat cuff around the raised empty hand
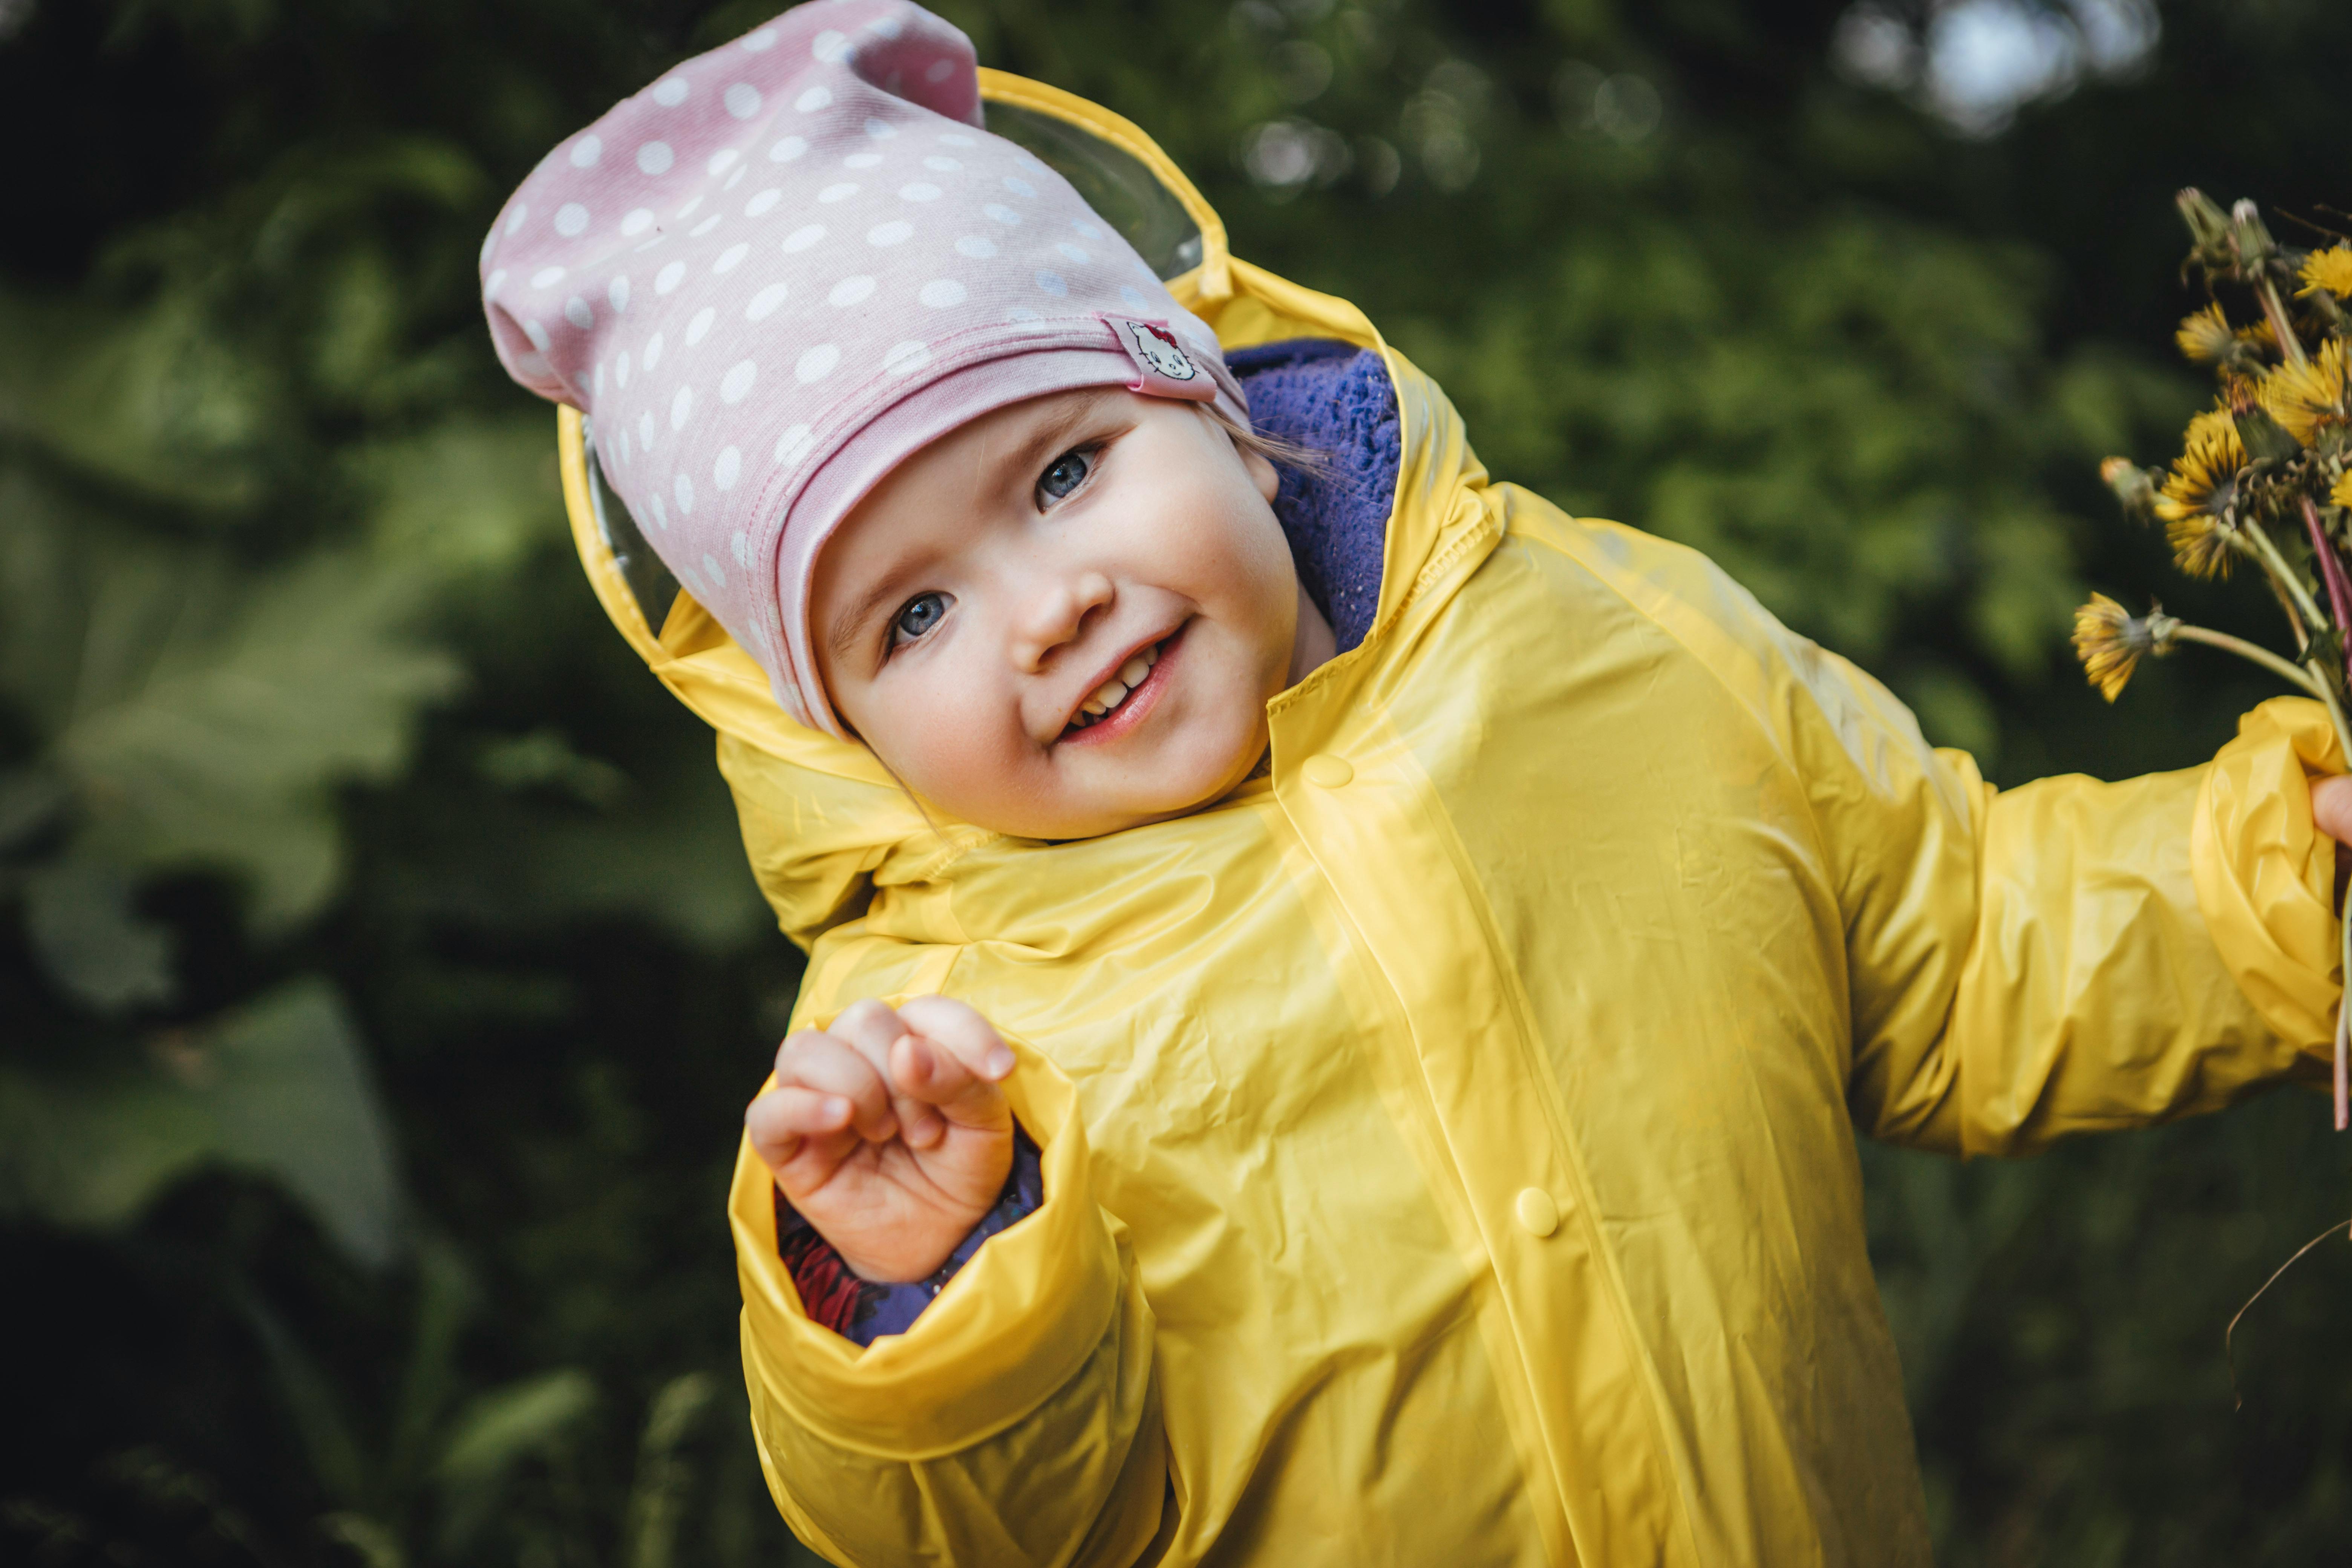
[727,1041,1124,1460]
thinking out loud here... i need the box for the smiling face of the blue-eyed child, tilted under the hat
[809,388,1320,839]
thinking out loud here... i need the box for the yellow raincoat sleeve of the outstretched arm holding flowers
[1785,644,2343,1154]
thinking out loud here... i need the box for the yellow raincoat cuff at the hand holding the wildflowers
[2190,698,2345,1055]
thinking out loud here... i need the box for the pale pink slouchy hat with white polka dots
[482,0,1246,736]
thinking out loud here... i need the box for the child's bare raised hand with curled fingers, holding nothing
[743,997,1014,1281]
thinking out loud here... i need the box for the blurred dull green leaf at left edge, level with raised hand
[0,978,398,1267]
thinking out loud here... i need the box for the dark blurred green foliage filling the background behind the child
[0,0,2352,1568]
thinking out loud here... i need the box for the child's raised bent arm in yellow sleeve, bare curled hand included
[729,997,1169,1568]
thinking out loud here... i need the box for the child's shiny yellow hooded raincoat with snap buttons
[565,73,2343,1568]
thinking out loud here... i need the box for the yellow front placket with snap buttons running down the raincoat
[1270,395,1696,1563]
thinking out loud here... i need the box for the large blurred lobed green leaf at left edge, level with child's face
[0,458,459,931]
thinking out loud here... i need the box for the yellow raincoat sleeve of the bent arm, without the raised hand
[729,1041,1169,1568]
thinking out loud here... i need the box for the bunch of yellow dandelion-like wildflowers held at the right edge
[2075,190,2352,1131]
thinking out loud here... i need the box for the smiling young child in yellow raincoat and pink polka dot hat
[482,0,2343,1566]
